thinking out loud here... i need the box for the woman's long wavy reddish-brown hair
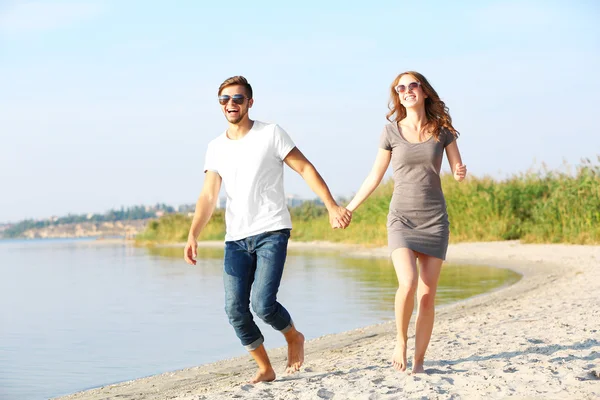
[386,71,459,141]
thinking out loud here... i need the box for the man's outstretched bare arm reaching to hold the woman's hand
[284,147,352,228]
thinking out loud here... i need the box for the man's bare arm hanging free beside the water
[183,171,222,265]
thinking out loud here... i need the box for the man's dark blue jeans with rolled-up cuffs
[223,229,292,351]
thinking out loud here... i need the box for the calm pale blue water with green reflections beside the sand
[0,240,518,400]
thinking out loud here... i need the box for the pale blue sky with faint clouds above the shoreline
[0,0,600,222]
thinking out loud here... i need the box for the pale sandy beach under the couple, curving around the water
[56,242,600,400]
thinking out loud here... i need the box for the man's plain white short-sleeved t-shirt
[204,121,295,241]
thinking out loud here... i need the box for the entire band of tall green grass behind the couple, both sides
[136,156,600,246]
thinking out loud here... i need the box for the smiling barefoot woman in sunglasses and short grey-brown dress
[347,71,467,373]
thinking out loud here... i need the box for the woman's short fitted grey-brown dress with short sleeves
[379,123,455,260]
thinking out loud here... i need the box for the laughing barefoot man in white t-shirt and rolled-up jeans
[184,76,352,383]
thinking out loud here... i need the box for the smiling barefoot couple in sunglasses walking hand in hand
[184,71,466,383]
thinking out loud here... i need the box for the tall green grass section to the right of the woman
[442,157,600,244]
